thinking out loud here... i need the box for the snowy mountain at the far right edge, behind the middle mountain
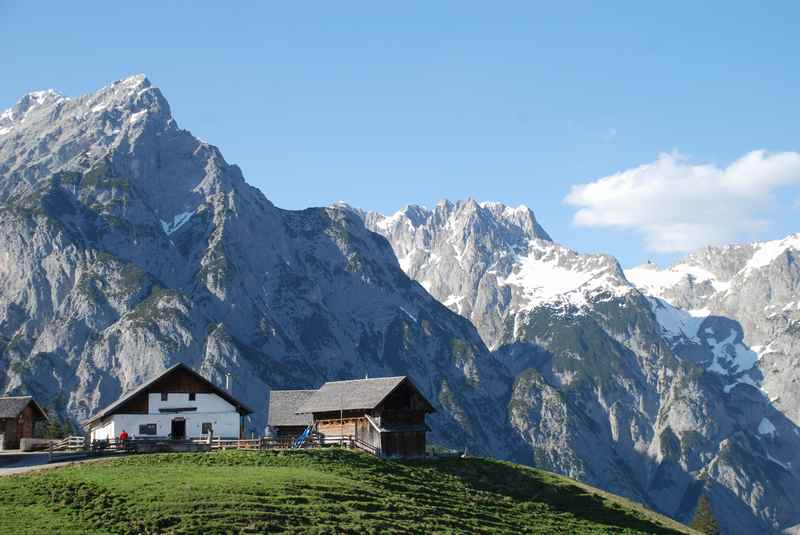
[626,235,800,425]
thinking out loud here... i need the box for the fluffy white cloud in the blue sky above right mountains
[564,150,800,253]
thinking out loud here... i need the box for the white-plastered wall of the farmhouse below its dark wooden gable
[90,393,240,440]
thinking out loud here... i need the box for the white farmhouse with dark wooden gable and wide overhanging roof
[83,363,253,441]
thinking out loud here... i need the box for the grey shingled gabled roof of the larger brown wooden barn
[297,375,434,414]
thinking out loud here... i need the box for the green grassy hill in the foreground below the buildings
[0,449,692,534]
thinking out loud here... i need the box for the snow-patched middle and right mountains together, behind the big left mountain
[360,200,800,533]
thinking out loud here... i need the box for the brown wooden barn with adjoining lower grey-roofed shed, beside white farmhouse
[270,376,434,457]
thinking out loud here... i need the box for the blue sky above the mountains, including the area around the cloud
[0,0,800,266]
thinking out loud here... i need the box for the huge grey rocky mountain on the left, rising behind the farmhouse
[0,76,516,453]
